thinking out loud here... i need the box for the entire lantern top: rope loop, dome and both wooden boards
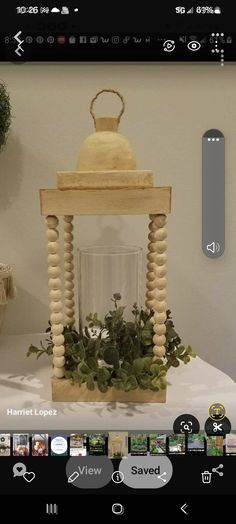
[40,89,171,216]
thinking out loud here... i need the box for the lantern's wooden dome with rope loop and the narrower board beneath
[54,89,154,190]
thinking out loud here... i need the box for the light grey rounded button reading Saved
[119,456,173,489]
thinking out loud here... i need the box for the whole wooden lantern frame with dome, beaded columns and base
[40,89,171,402]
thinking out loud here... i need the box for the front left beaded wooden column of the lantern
[46,215,65,378]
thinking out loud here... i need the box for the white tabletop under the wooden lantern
[0,334,236,431]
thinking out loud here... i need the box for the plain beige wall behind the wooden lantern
[0,64,236,378]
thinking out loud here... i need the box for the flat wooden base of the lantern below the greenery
[52,377,166,403]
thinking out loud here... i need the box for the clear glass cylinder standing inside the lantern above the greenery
[78,245,142,329]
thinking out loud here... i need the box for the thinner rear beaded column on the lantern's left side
[64,215,75,326]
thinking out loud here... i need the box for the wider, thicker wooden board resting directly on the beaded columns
[40,187,171,216]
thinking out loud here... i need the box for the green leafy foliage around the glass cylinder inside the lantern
[27,293,196,393]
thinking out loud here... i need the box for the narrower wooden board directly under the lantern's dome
[57,169,154,190]
